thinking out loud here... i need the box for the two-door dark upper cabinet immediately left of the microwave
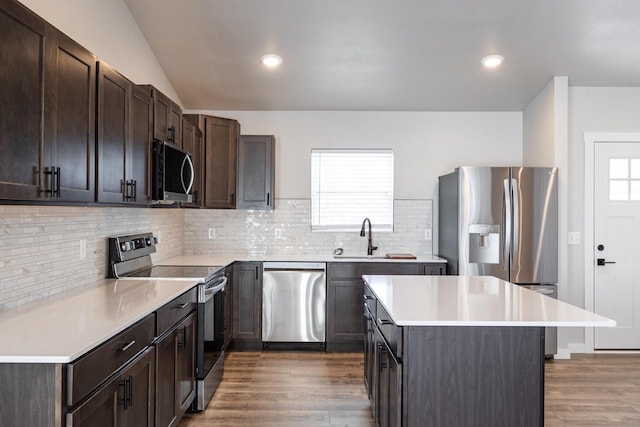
[97,62,153,205]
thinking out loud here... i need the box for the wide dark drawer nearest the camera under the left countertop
[66,314,155,406]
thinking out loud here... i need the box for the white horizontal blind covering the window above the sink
[311,149,393,232]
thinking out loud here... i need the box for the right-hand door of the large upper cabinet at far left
[44,30,96,202]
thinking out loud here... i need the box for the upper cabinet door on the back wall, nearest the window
[237,135,275,209]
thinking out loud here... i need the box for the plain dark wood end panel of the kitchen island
[402,326,544,427]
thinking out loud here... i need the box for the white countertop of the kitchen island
[364,276,616,327]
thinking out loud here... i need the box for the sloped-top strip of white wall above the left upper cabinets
[20,0,180,103]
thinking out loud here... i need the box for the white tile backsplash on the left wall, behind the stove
[0,205,184,311]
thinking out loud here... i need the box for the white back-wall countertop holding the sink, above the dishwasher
[154,253,447,266]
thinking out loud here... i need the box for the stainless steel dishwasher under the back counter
[262,262,327,350]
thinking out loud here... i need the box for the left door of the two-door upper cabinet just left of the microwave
[97,62,133,203]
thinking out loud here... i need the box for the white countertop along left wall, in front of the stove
[0,279,196,363]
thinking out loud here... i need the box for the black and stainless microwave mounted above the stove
[151,141,194,204]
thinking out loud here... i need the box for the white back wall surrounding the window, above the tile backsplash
[188,111,522,202]
